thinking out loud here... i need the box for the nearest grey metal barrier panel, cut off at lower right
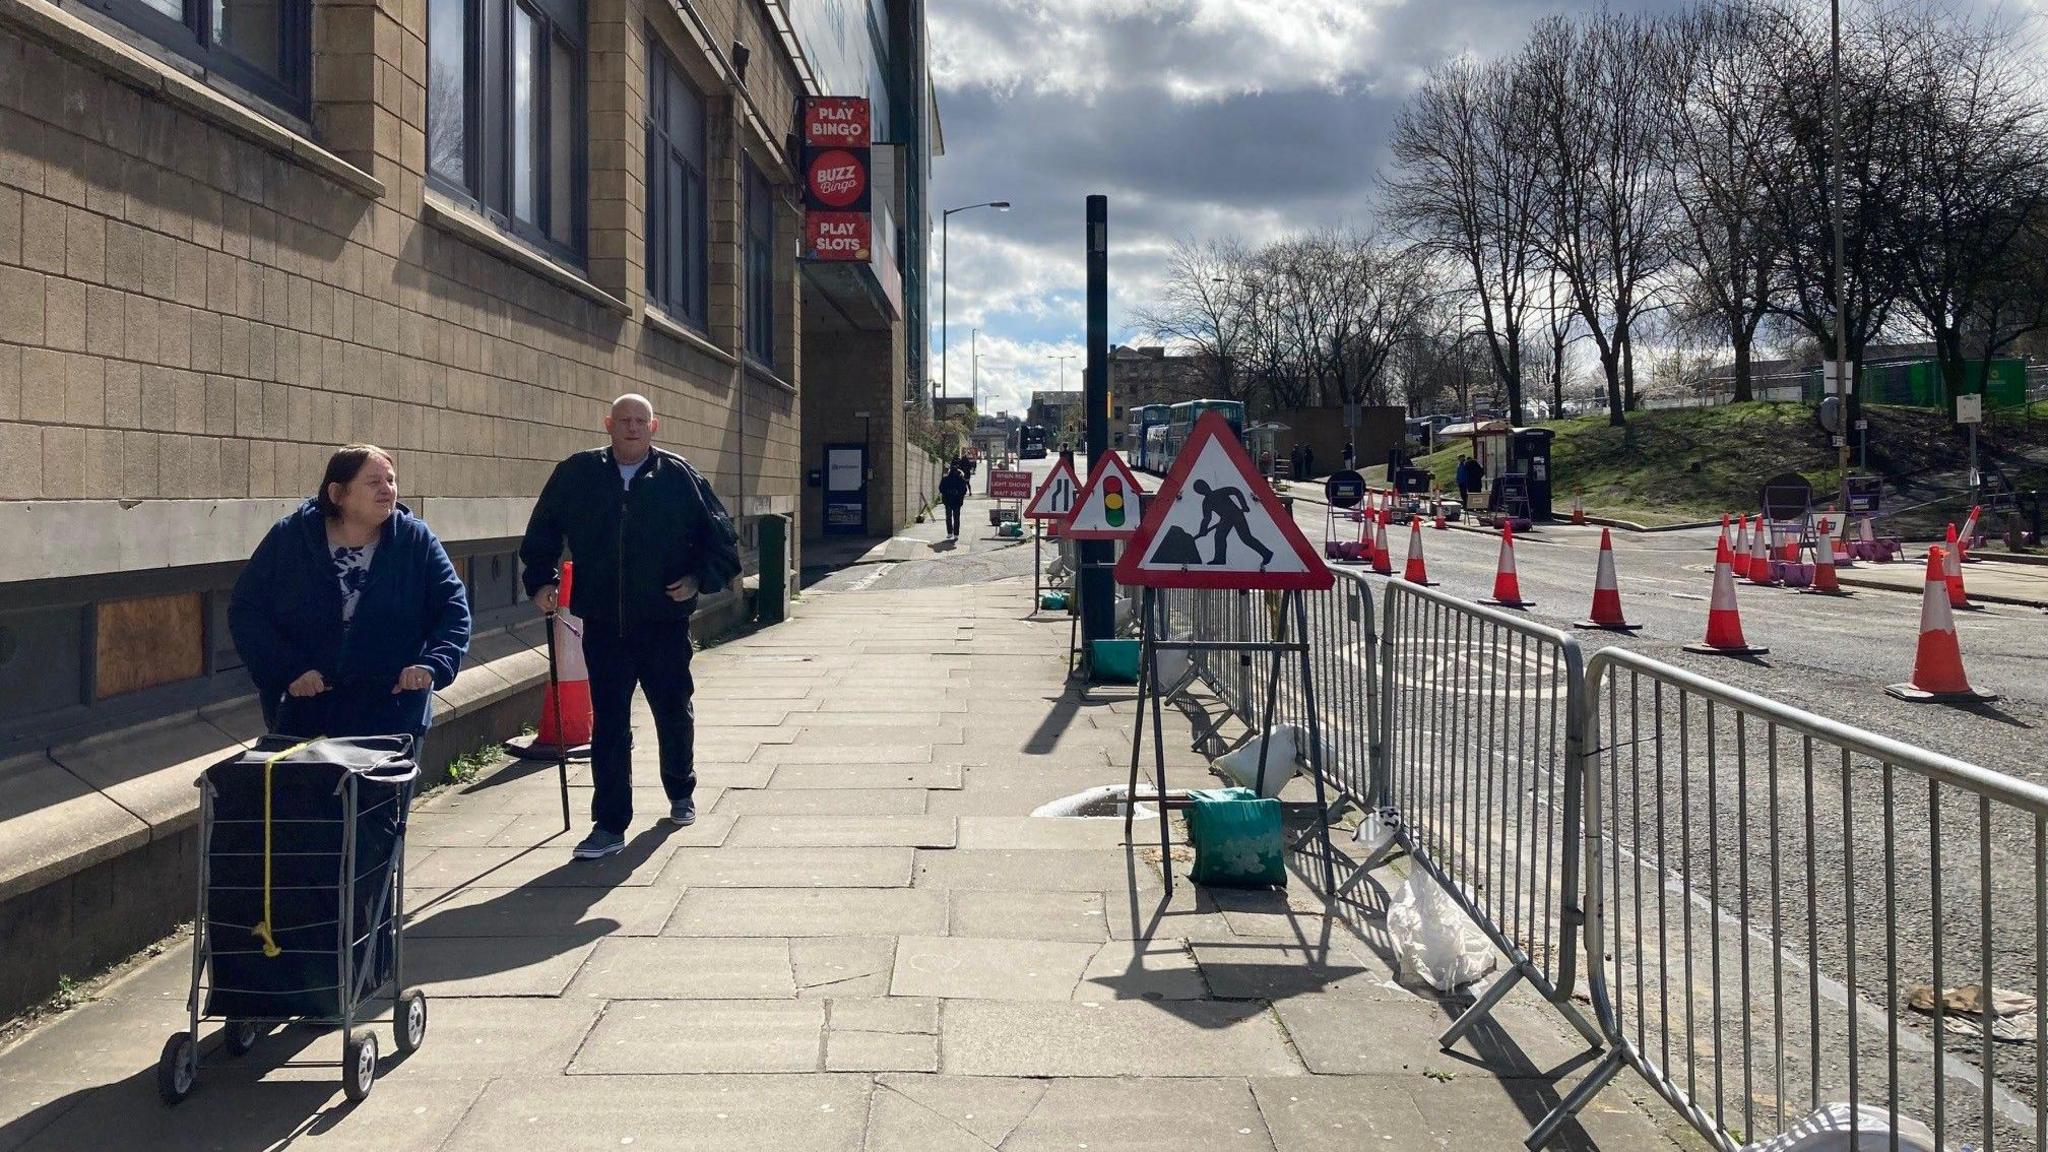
[1572,648,2048,1150]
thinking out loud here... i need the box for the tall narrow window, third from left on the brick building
[647,39,709,328]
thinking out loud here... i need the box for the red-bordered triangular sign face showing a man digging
[1116,412,1335,590]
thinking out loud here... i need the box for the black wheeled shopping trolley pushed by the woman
[158,736,426,1103]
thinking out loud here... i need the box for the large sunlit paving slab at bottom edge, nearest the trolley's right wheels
[446,1076,868,1152]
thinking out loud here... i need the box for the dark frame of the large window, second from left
[423,0,590,269]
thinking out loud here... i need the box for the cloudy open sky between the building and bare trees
[928,0,1613,410]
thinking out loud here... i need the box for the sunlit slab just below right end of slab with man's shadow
[567,937,797,1000]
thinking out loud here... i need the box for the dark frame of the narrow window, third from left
[643,35,711,332]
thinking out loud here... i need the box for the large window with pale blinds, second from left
[426,0,584,260]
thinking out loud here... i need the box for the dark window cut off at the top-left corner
[88,0,313,117]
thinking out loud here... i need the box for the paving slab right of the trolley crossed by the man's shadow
[406,886,682,939]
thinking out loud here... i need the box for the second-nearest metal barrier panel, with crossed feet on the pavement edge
[1380,580,1599,1045]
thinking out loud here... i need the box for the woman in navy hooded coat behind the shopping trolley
[227,445,469,740]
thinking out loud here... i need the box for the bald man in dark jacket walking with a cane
[520,394,739,861]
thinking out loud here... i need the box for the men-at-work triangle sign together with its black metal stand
[1116,412,1335,896]
